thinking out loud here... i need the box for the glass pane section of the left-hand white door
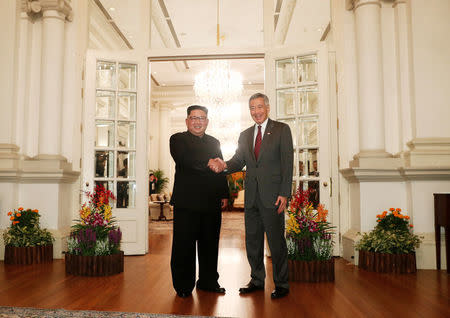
[94,60,137,209]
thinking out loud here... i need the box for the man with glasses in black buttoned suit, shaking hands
[170,105,229,298]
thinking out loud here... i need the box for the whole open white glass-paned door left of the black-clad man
[82,50,149,255]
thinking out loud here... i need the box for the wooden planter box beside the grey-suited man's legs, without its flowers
[288,258,334,283]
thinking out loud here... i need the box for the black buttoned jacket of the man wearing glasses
[170,131,229,210]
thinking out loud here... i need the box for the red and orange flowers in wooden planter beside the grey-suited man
[286,188,334,282]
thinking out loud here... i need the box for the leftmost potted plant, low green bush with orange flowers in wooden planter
[3,207,54,265]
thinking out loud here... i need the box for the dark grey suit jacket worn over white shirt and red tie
[227,119,294,208]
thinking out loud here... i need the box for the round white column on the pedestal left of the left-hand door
[39,1,68,157]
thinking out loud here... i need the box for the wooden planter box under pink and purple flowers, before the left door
[65,251,123,276]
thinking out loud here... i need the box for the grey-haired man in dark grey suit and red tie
[210,93,293,299]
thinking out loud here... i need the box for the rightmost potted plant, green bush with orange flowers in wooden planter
[355,208,421,273]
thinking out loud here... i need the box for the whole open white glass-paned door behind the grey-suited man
[266,44,340,255]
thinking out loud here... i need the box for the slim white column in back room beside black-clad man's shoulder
[159,104,171,177]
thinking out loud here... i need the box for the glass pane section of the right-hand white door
[275,54,320,207]
